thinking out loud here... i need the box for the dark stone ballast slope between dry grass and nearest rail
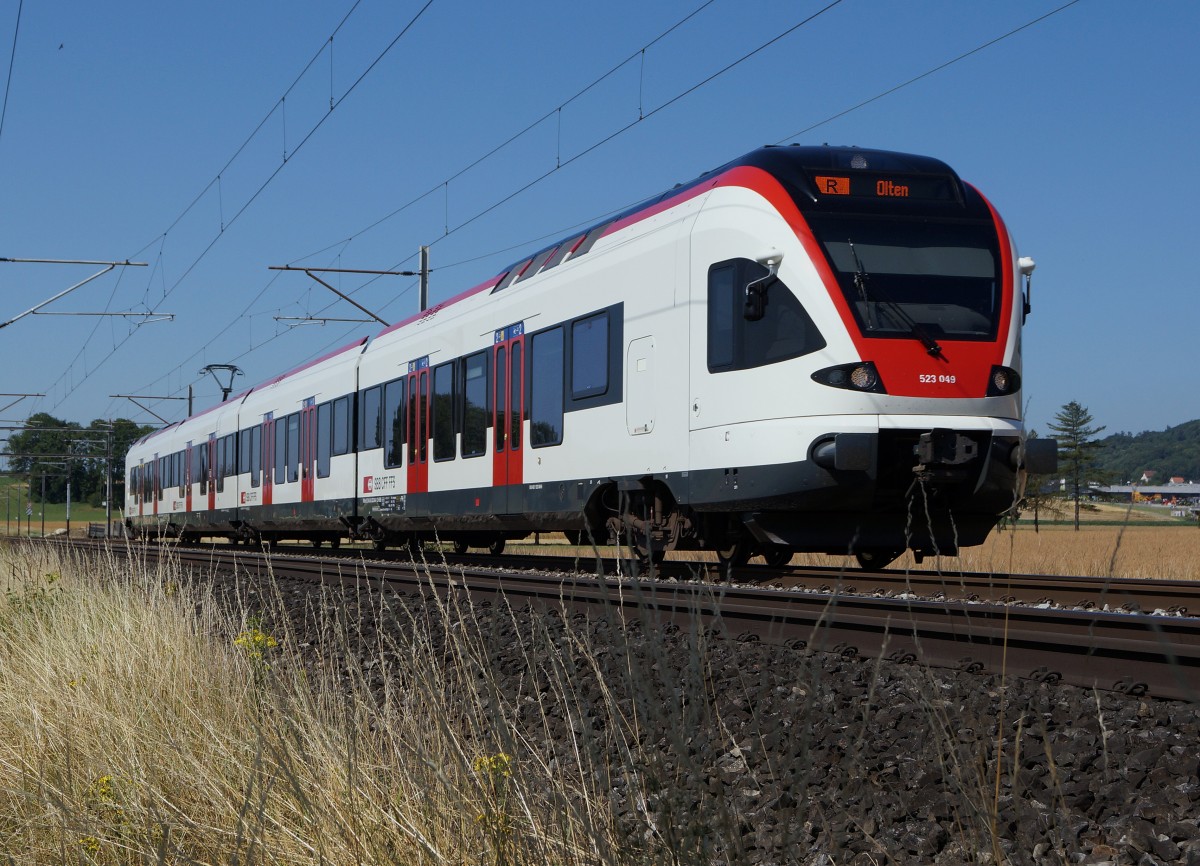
[223,579,1200,866]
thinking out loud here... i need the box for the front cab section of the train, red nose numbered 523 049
[690,149,1048,564]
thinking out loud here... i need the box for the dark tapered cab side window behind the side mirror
[708,259,826,373]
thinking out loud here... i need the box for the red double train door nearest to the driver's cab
[492,323,526,513]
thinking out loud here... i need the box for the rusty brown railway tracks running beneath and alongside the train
[49,532,1200,700]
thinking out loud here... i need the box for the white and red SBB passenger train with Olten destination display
[124,145,1056,567]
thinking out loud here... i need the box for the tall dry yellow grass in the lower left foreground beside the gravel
[0,545,628,866]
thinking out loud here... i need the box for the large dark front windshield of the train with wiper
[808,215,1002,345]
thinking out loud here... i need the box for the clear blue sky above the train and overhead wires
[0,0,1200,432]
